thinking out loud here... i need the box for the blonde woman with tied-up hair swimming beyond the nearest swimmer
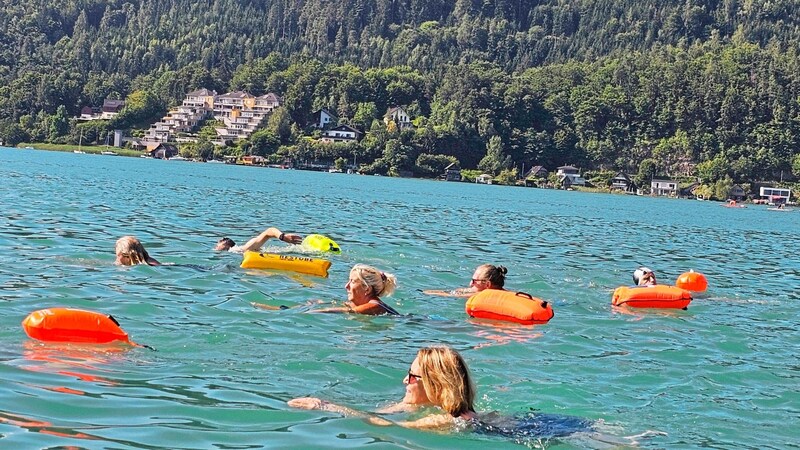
[251,264,400,316]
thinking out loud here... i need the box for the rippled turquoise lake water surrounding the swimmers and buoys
[0,148,800,449]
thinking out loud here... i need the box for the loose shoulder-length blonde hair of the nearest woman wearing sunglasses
[417,346,475,417]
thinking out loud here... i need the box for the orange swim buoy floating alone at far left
[22,308,136,345]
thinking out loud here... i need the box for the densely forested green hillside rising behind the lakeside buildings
[0,0,800,193]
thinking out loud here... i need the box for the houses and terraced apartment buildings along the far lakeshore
[26,89,796,207]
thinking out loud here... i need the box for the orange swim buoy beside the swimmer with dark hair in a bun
[466,289,554,325]
